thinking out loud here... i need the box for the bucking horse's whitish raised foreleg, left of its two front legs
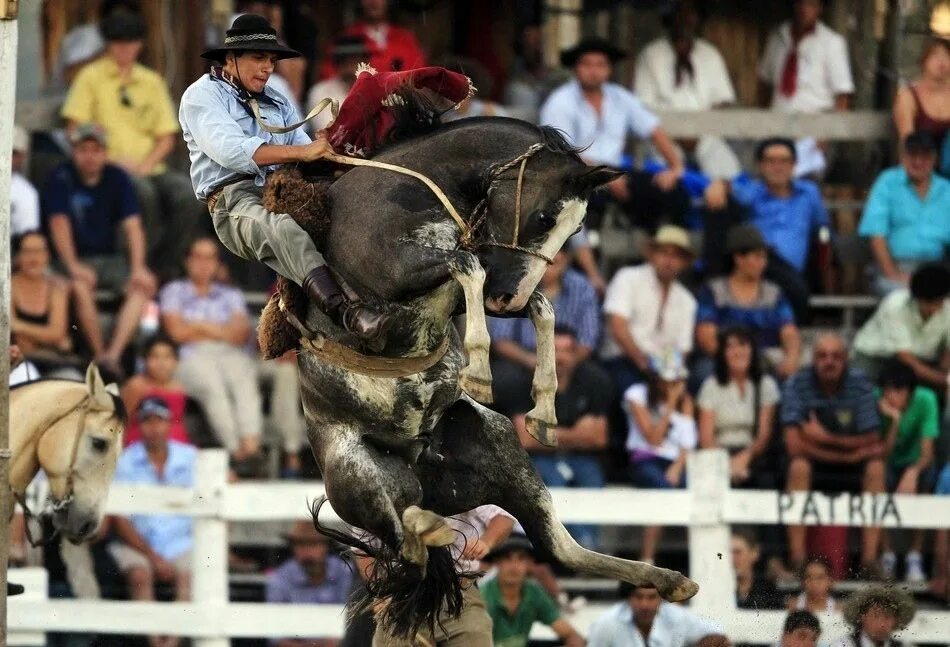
[451,253,492,404]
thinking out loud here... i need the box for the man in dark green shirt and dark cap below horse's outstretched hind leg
[479,535,584,647]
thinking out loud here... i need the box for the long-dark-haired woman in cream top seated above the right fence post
[698,327,779,485]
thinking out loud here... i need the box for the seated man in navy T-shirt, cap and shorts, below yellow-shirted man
[43,124,157,373]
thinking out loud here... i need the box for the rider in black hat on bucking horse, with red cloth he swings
[179,14,471,340]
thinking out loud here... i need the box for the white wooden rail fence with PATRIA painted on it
[9,450,950,647]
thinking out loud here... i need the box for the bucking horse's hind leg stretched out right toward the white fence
[423,399,698,601]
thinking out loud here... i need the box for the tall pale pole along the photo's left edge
[0,0,17,647]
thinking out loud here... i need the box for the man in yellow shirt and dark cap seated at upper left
[62,10,202,278]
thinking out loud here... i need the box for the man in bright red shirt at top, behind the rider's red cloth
[320,0,426,79]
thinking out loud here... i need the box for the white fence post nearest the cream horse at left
[191,449,231,647]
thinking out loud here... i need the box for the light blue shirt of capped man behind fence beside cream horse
[115,440,198,560]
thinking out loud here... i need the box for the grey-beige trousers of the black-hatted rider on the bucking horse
[211,180,326,285]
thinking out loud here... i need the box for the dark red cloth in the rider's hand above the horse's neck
[327,64,475,155]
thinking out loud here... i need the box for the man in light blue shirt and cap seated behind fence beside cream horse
[109,397,198,647]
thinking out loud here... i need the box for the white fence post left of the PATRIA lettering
[686,449,736,619]
